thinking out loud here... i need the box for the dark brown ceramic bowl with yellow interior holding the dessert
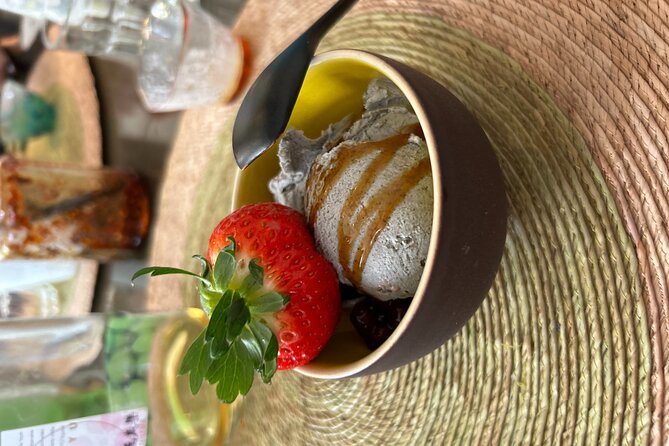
[233,50,506,379]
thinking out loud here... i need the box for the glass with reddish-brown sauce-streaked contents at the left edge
[0,155,149,261]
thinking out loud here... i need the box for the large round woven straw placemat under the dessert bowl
[150,0,669,445]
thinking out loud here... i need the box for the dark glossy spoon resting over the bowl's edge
[232,0,356,169]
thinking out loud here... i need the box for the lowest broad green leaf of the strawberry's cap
[207,340,254,403]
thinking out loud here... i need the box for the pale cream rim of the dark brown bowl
[232,49,444,379]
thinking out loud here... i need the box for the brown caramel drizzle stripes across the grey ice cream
[307,124,431,286]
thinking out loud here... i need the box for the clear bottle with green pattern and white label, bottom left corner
[0,309,231,446]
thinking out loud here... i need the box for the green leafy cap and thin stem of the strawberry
[132,237,289,403]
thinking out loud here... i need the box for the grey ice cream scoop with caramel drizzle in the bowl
[270,78,433,300]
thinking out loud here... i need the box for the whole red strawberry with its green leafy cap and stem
[133,203,340,402]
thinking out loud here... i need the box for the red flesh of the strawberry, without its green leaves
[208,203,340,370]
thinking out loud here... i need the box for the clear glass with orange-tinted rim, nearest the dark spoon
[138,0,243,111]
